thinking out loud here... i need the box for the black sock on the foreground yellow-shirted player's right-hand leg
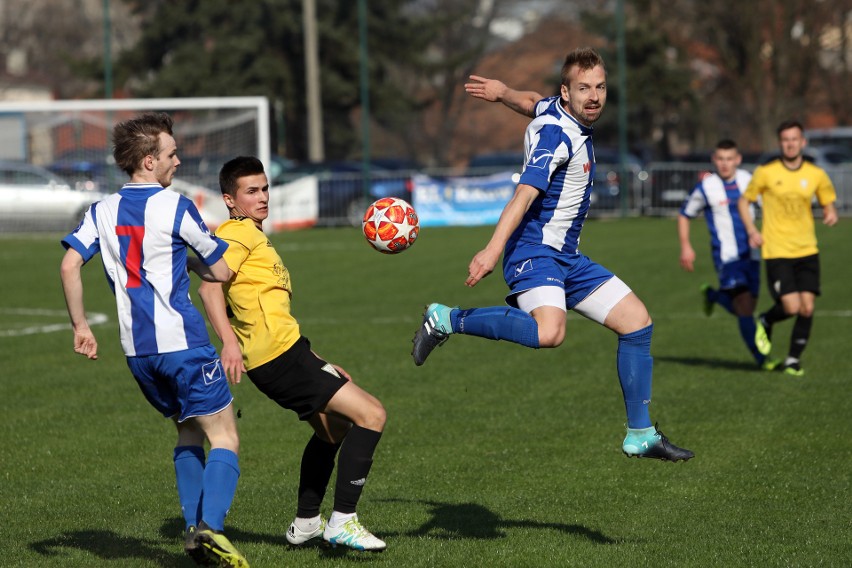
[334,426,382,513]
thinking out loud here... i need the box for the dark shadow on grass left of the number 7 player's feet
[29,530,195,567]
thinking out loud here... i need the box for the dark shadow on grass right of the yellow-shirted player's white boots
[384,499,617,544]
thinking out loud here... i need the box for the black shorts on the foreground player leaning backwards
[247,337,348,420]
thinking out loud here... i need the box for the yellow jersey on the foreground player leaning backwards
[216,218,300,370]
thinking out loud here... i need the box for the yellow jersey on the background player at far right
[743,159,837,259]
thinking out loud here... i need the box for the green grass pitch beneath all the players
[0,215,852,568]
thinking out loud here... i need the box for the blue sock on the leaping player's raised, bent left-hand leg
[450,306,538,349]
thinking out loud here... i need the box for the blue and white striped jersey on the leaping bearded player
[507,97,595,254]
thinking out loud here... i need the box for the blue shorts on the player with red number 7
[127,345,233,422]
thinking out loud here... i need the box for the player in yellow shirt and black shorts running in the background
[738,120,837,376]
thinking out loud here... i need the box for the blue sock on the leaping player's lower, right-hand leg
[616,324,654,429]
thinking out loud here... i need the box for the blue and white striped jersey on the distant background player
[680,170,757,268]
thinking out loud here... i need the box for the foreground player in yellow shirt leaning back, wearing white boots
[199,156,385,550]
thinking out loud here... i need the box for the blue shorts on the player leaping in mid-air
[503,247,614,310]
